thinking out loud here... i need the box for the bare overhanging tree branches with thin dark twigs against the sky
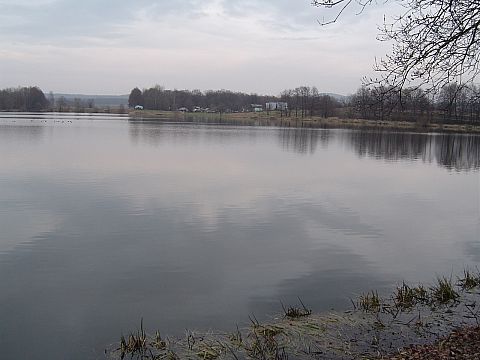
[312,0,480,90]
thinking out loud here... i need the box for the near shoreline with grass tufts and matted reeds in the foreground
[106,271,480,360]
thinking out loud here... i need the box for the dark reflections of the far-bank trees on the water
[129,120,480,171]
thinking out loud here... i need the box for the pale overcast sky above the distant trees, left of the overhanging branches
[0,0,395,95]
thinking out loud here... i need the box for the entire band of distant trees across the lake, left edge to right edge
[0,83,480,125]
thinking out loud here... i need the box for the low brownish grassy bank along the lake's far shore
[129,110,480,134]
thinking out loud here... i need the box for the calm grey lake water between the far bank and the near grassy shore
[0,113,480,360]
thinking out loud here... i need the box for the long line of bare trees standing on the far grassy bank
[129,83,480,125]
